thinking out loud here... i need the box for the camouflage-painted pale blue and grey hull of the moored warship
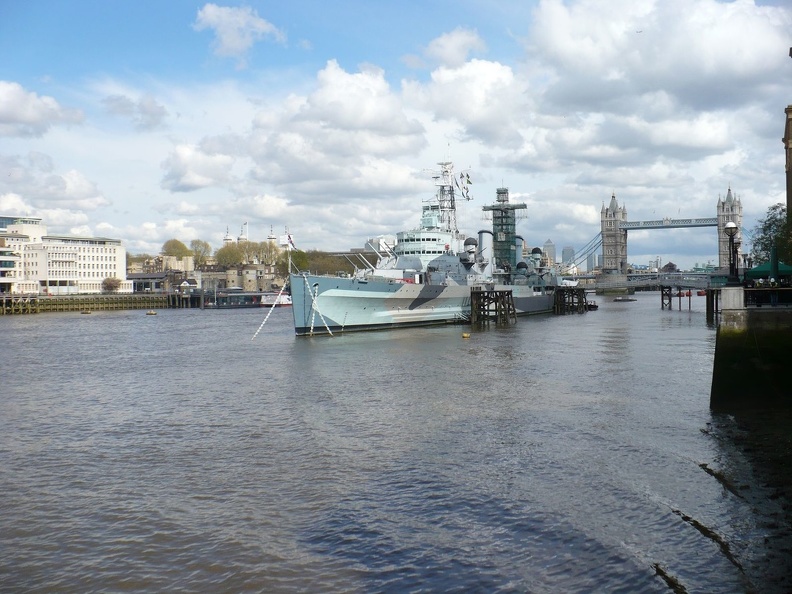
[291,274,553,336]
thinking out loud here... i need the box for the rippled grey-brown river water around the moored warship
[0,293,792,593]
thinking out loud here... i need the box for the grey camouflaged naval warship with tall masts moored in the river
[289,161,558,336]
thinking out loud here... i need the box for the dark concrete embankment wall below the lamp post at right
[710,308,792,412]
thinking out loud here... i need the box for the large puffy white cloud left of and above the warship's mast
[244,60,425,204]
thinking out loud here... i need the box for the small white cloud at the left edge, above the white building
[0,81,83,137]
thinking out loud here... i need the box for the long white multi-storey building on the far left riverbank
[0,217,132,295]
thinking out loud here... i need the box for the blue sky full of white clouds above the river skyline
[0,0,792,268]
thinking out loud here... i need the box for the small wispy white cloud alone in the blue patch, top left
[193,3,286,68]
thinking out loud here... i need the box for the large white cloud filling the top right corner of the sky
[528,0,792,111]
